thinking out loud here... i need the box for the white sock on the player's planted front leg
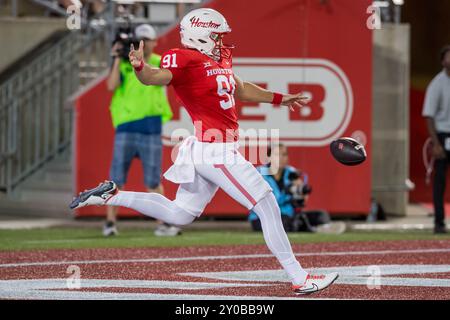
[253,192,308,285]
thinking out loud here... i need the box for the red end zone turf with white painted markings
[0,240,450,300]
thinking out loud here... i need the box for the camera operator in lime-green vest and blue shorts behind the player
[103,24,180,236]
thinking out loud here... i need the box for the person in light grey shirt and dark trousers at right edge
[422,46,450,234]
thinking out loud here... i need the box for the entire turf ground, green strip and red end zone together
[0,228,450,300]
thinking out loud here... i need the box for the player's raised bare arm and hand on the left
[129,41,172,86]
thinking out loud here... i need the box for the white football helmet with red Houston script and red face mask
[180,8,233,60]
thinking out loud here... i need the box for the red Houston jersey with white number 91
[161,49,239,142]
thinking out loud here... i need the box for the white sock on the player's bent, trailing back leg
[106,191,195,226]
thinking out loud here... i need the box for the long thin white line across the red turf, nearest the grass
[0,248,450,268]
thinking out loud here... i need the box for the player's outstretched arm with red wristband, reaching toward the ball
[234,75,308,110]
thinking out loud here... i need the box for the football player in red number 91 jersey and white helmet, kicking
[70,9,338,294]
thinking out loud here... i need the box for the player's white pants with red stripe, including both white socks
[108,141,307,285]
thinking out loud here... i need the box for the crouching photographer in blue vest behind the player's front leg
[249,144,311,232]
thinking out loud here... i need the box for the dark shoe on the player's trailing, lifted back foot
[69,181,117,209]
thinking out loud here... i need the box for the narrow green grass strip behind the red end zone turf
[0,228,450,250]
